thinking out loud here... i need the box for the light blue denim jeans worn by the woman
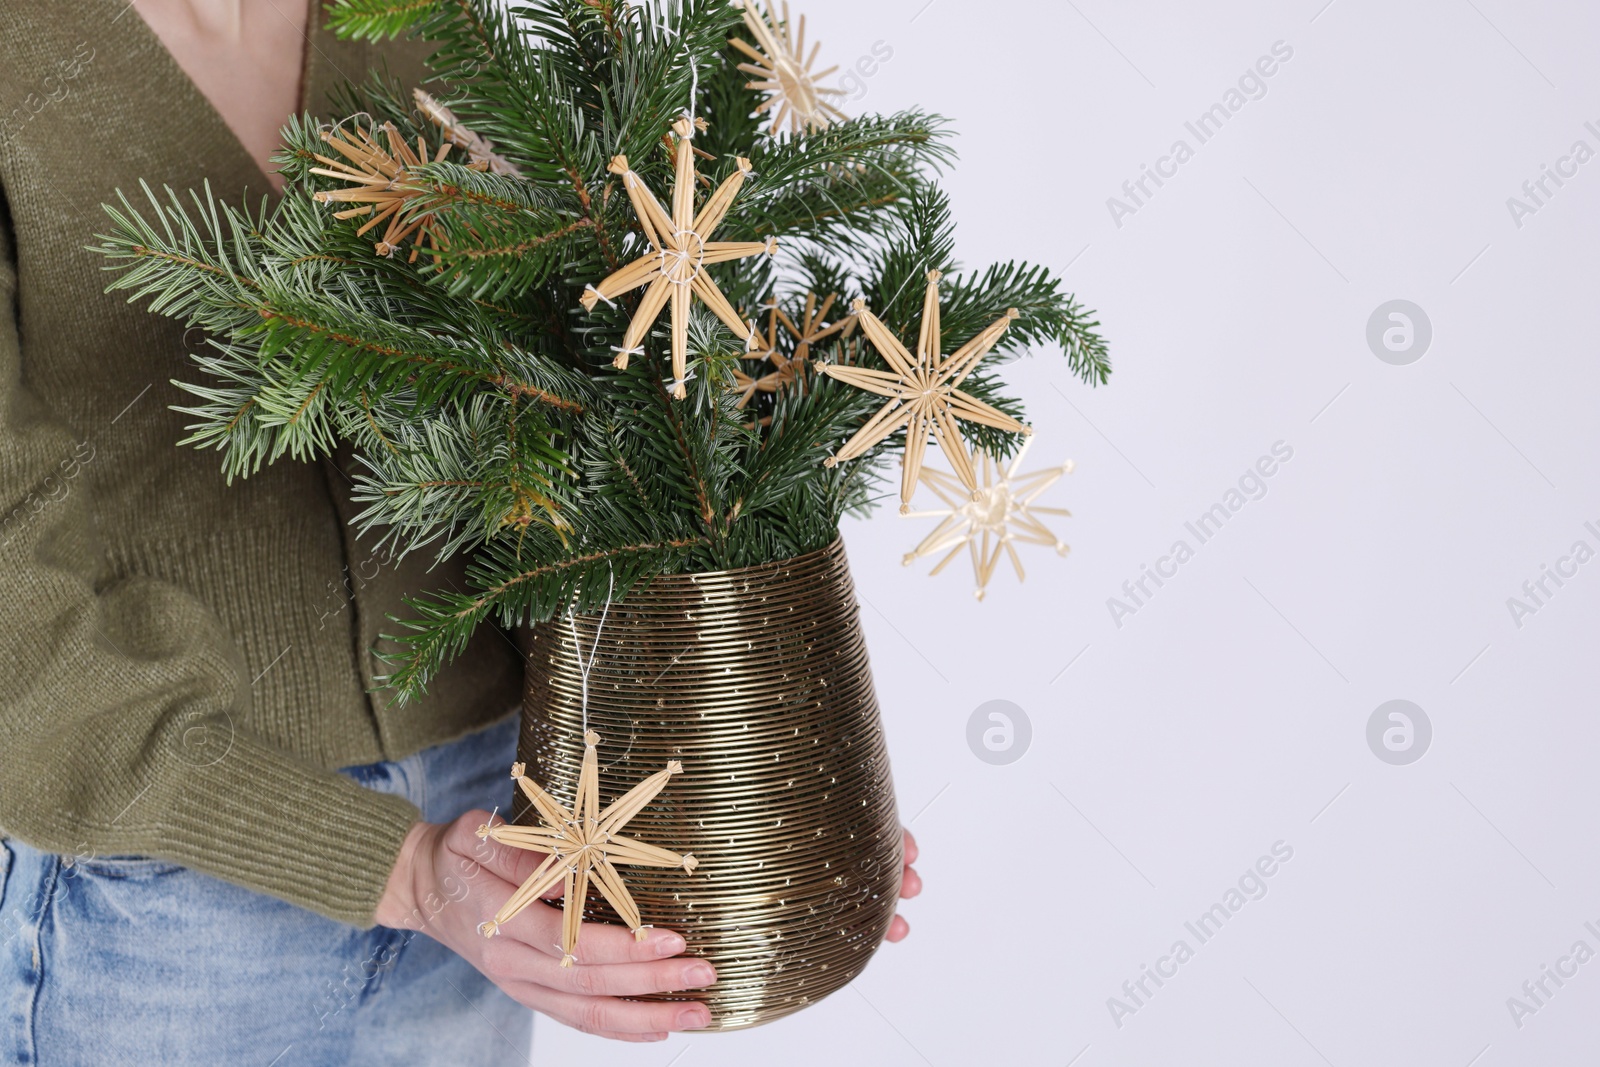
[0,717,533,1067]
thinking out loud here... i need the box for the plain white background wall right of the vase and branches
[534,0,1600,1067]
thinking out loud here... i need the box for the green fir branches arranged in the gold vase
[99,0,1110,699]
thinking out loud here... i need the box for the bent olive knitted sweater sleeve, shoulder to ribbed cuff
[0,226,418,926]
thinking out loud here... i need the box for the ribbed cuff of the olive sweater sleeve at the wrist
[163,736,421,928]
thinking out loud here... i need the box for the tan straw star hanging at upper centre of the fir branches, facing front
[582,118,778,400]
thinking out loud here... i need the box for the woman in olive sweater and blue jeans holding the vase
[0,0,918,1067]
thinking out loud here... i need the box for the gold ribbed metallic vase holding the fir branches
[520,541,902,1030]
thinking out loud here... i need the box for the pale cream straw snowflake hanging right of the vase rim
[902,440,1074,600]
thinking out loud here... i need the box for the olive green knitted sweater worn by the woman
[0,0,522,926]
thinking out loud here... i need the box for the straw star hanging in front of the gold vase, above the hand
[478,731,696,966]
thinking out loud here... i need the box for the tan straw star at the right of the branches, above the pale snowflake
[818,270,1034,515]
